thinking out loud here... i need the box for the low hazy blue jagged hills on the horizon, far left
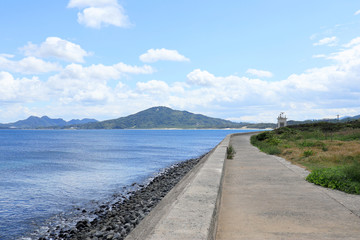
[0,116,97,129]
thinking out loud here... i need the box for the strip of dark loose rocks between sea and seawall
[38,155,205,240]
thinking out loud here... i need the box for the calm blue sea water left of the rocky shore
[0,130,256,240]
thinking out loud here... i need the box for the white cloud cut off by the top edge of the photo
[68,0,131,28]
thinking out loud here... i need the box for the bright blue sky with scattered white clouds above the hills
[0,0,360,123]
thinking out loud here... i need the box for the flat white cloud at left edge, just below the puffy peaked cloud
[0,54,61,74]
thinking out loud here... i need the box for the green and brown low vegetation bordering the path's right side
[251,120,360,194]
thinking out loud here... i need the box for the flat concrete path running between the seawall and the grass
[216,135,360,240]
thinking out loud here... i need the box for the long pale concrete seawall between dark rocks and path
[125,132,242,240]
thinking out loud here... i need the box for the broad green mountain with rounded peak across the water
[73,107,246,129]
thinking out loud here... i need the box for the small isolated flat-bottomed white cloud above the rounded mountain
[139,48,190,63]
